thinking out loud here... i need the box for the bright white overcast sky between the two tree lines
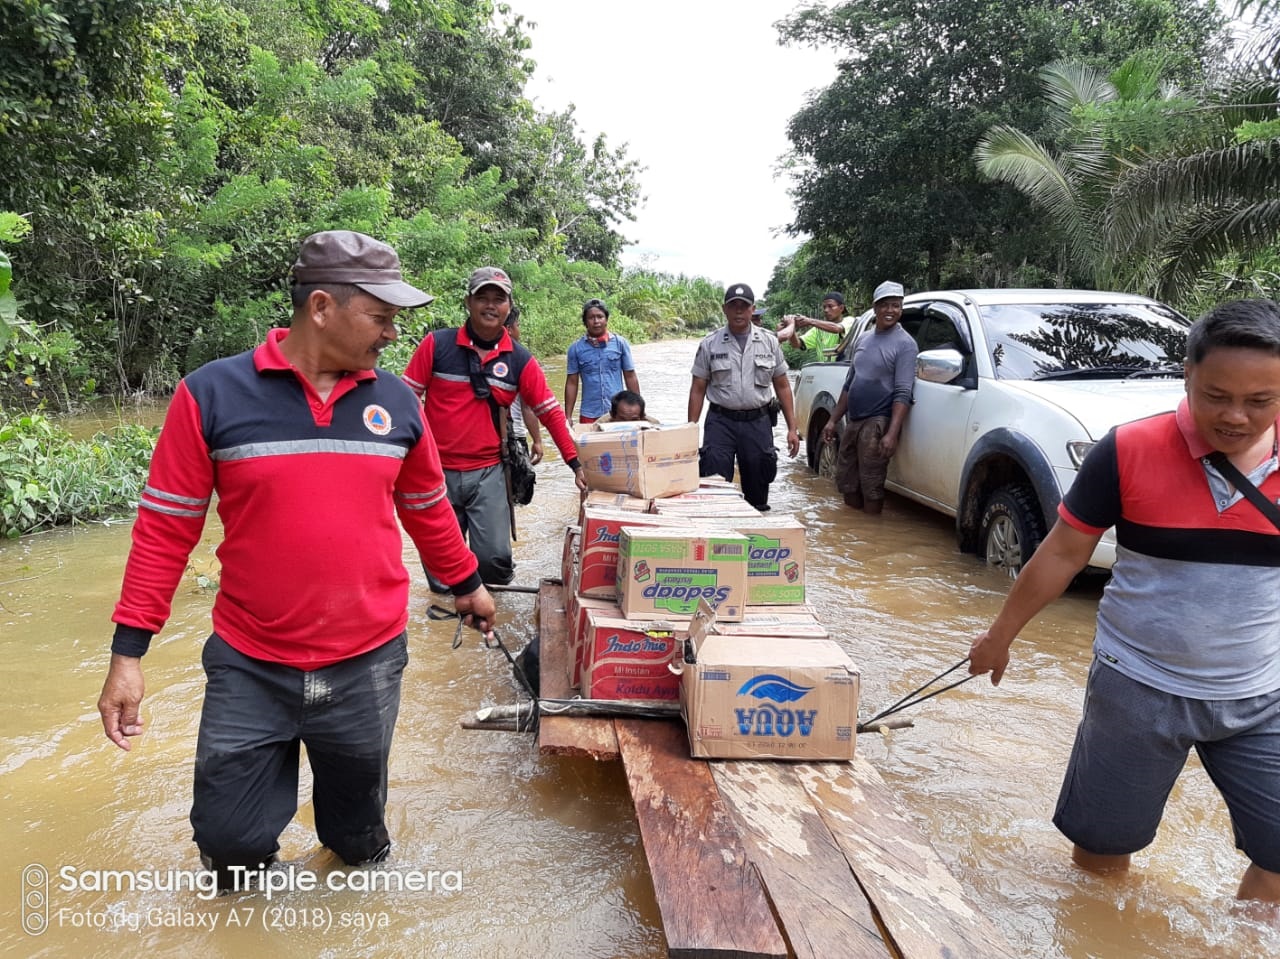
[509,0,836,296]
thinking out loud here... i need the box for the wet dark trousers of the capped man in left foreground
[191,633,408,874]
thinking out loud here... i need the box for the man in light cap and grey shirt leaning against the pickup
[822,280,916,513]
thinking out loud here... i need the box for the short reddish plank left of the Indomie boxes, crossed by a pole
[538,580,618,762]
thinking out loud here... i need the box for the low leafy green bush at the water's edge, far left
[0,414,157,539]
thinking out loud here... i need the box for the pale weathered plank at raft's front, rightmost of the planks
[795,758,1016,959]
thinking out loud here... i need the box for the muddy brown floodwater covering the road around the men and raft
[0,342,1280,959]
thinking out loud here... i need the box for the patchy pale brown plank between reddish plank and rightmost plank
[709,762,895,959]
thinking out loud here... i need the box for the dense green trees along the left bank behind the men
[0,0,718,408]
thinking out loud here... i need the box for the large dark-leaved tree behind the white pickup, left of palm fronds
[780,0,1222,293]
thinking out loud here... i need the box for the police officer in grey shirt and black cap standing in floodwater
[689,283,800,512]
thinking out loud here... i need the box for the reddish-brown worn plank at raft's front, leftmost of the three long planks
[614,720,787,959]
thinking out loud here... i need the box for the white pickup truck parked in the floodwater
[795,289,1190,576]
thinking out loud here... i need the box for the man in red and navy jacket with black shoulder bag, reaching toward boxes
[404,266,586,590]
